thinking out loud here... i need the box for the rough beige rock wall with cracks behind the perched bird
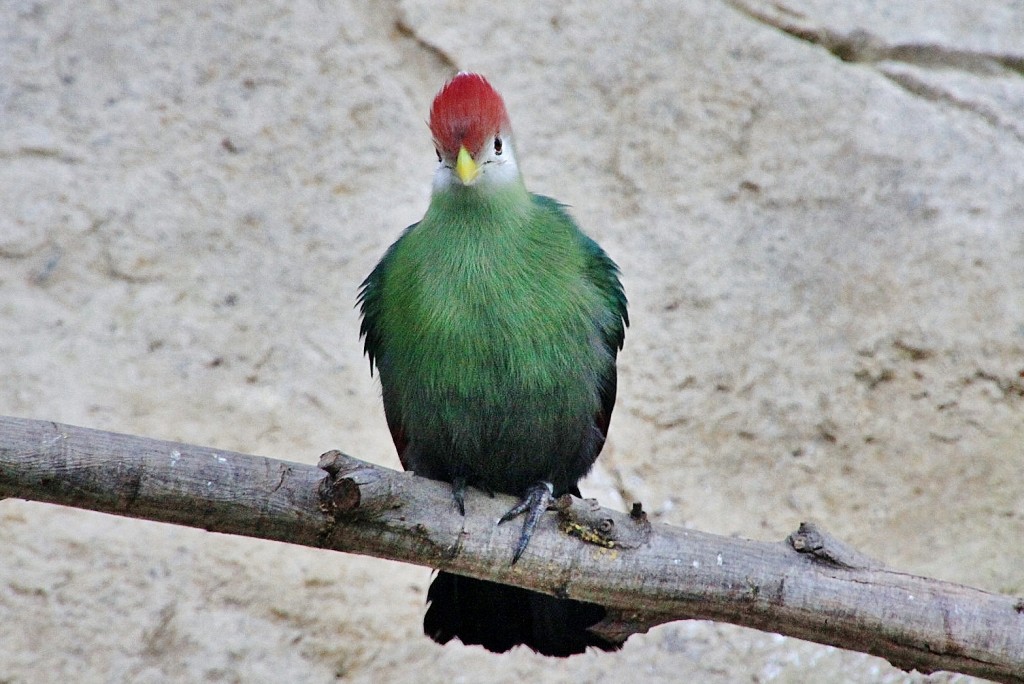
[0,0,1024,684]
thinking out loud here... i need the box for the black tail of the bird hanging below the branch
[423,572,622,657]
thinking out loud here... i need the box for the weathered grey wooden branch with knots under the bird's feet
[0,417,1024,683]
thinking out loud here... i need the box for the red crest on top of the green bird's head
[430,72,511,158]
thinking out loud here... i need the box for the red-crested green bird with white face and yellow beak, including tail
[357,72,629,657]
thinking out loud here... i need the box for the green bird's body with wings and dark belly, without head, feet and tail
[359,181,628,496]
